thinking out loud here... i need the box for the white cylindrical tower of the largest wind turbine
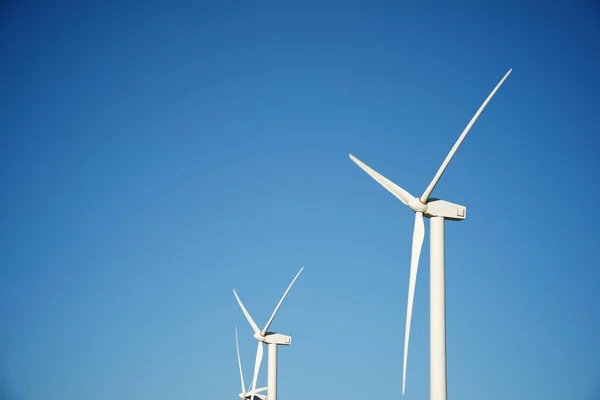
[429,217,446,400]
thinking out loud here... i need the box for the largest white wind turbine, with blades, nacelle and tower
[350,68,512,400]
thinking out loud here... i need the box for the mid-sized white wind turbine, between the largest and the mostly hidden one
[233,267,304,400]
